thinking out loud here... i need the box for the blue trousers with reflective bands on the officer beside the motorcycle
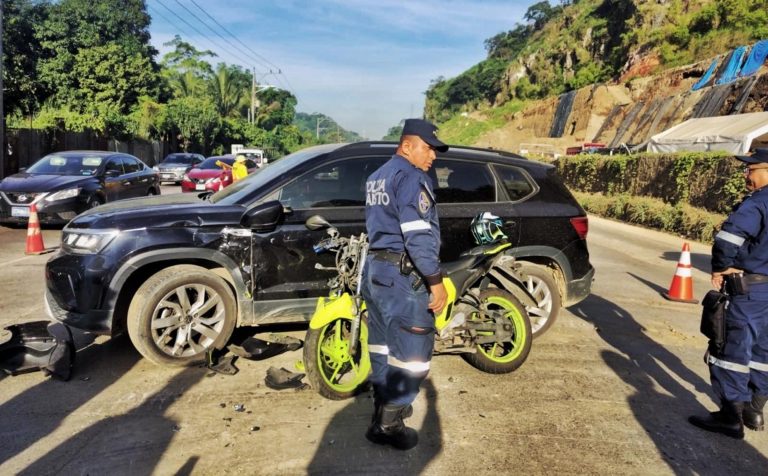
[362,256,435,405]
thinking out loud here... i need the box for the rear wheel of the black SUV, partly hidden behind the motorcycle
[520,261,562,339]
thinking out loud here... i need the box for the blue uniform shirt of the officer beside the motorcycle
[365,154,441,284]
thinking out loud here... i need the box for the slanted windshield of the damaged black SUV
[211,144,344,204]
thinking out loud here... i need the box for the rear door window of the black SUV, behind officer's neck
[428,159,496,204]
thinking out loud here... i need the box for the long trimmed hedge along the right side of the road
[553,153,747,243]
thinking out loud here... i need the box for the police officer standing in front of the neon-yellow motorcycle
[362,119,448,450]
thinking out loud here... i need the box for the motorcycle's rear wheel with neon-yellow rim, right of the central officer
[462,288,533,374]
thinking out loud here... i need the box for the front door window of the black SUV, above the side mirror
[278,157,387,208]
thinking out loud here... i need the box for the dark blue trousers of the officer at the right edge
[709,284,768,402]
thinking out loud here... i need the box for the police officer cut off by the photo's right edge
[688,149,768,439]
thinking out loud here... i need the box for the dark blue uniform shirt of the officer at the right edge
[712,187,768,276]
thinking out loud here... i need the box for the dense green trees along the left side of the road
[2,0,354,157]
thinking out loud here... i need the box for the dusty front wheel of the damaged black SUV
[127,265,237,366]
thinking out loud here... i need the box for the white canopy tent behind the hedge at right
[648,111,768,155]
